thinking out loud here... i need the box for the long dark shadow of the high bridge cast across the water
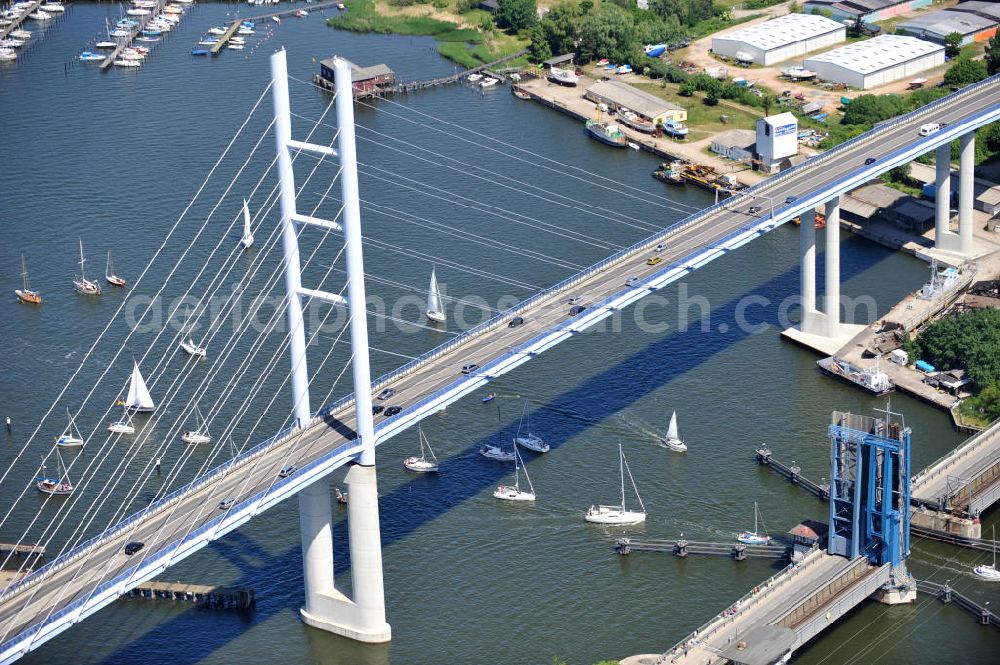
[90,237,893,665]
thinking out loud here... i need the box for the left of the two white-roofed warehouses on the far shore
[712,14,847,65]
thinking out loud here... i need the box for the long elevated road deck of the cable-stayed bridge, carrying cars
[0,74,1000,663]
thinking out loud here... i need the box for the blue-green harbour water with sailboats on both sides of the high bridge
[0,5,997,665]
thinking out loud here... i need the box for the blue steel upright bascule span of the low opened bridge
[827,406,910,574]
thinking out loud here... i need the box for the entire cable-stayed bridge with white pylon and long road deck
[0,53,1000,662]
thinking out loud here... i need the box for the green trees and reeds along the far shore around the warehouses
[327,0,1000,160]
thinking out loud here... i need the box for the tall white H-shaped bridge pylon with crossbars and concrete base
[271,50,392,642]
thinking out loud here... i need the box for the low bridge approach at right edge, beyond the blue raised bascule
[910,421,1000,514]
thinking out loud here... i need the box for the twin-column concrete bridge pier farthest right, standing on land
[934,132,976,256]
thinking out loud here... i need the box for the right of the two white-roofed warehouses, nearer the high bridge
[803,35,944,90]
